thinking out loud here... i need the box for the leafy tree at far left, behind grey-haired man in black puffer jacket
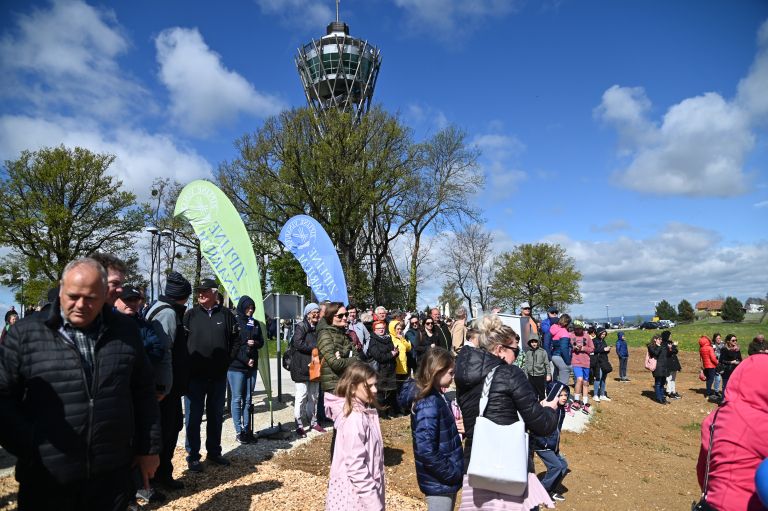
[0,146,146,282]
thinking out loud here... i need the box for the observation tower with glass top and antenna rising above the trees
[295,0,381,123]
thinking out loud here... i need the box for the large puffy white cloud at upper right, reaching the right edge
[595,21,768,197]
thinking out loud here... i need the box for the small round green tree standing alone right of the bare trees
[491,243,581,311]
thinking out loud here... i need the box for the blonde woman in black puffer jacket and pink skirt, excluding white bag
[455,315,558,511]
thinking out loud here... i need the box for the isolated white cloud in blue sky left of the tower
[155,27,283,135]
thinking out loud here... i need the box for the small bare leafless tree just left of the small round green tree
[446,224,493,311]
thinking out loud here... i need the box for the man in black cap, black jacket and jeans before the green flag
[184,279,239,472]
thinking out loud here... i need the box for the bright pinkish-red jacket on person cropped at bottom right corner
[696,354,768,511]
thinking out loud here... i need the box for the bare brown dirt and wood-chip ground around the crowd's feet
[0,349,714,511]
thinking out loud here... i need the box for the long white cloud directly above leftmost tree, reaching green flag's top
[0,115,211,200]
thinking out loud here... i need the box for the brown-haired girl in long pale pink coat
[325,362,384,511]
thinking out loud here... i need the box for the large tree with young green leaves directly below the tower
[217,108,418,303]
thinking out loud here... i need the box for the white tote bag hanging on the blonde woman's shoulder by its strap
[467,368,528,497]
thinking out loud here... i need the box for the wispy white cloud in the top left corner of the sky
[0,0,153,120]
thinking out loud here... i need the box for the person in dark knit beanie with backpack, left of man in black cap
[146,271,192,490]
